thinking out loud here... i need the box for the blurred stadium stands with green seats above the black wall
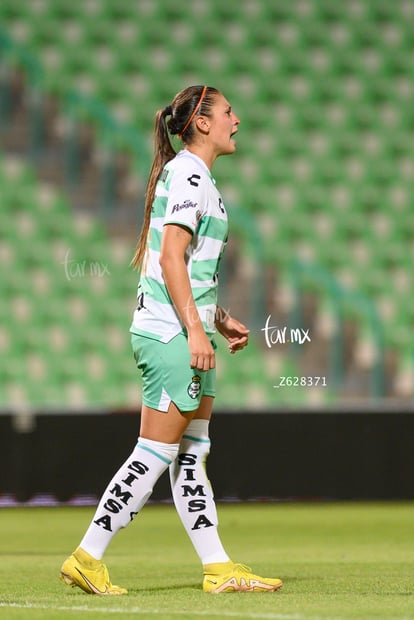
[0,0,414,502]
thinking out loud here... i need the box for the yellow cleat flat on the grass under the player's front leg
[203,562,283,594]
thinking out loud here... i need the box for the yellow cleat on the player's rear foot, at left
[60,547,128,596]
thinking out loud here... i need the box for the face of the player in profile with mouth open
[204,93,240,155]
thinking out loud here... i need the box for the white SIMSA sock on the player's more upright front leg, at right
[170,420,229,564]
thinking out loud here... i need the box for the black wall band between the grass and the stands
[0,411,414,505]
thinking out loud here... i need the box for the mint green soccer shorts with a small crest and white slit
[131,333,216,412]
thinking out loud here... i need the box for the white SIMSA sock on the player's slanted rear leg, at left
[79,437,179,560]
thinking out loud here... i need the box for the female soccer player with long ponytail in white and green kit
[61,86,282,594]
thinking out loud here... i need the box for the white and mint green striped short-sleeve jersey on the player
[130,150,228,342]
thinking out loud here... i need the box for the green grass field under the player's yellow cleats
[0,503,414,620]
